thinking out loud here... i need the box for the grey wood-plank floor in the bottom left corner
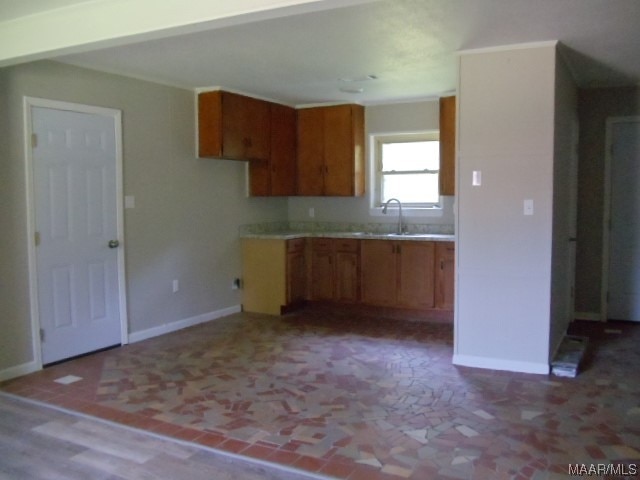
[0,393,326,480]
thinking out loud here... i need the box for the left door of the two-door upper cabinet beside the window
[297,108,325,196]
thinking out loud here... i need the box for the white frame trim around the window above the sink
[369,130,443,217]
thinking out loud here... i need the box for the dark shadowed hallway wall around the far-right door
[576,87,640,319]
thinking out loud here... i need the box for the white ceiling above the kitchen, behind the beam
[8,0,640,105]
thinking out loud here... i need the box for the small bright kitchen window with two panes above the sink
[374,132,440,208]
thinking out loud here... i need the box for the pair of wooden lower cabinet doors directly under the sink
[360,240,435,309]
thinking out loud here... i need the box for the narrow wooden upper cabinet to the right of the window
[440,96,456,195]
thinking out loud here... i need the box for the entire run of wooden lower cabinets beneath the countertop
[242,238,455,315]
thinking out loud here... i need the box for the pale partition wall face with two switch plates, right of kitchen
[454,45,556,373]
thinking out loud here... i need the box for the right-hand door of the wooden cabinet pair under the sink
[397,241,435,308]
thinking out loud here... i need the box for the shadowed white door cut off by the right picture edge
[607,120,640,322]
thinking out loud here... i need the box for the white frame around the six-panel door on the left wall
[23,96,129,370]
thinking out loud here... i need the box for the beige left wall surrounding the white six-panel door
[0,62,287,374]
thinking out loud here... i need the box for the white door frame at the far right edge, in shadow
[600,116,640,322]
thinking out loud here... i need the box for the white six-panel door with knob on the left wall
[31,107,121,364]
